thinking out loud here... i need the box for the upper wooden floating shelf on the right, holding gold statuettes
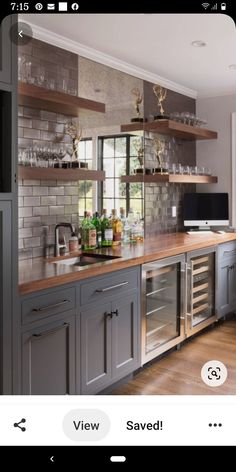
[121,120,217,141]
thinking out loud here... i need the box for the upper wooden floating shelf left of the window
[18,82,105,116]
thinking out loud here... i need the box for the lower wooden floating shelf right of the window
[121,174,218,184]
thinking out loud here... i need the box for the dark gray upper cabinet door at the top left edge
[0,16,12,84]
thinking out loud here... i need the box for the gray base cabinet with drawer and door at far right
[217,241,236,318]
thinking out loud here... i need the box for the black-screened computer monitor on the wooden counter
[183,193,229,229]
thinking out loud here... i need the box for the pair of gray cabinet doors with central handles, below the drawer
[81,291,140,394]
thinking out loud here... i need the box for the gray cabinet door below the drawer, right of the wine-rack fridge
[218,261,230,318]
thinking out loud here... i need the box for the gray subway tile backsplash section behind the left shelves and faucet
[18,39,79,259]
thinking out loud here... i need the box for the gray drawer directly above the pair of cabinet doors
[80,268,139,305]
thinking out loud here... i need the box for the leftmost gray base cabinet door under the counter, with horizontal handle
[22,314,75,395]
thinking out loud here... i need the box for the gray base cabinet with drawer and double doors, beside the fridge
[80,267,140,394]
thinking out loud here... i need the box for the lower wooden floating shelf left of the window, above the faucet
[18,166,105,181]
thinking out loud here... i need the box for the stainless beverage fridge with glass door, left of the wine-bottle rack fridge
[142,255,186,364]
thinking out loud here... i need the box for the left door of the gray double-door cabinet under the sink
[81,303,112,394]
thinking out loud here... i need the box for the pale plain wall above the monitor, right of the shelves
[196,95,236,223]
